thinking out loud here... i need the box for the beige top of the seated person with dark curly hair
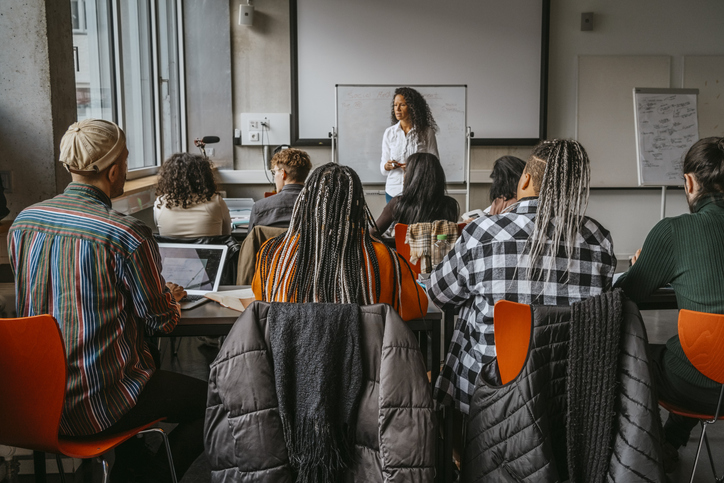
[153,193,231,238]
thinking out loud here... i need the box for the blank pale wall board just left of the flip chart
[576,55,671,188]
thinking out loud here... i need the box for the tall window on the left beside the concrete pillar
[71,0,184,174]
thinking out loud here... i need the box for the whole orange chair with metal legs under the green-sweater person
[659,309,724,482]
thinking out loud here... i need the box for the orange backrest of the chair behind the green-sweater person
[679,309,724,384]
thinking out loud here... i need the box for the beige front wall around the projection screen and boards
[229,0,724,258]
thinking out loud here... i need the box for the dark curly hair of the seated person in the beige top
[156,153,216,209]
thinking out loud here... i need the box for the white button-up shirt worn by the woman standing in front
[380,122,440,197]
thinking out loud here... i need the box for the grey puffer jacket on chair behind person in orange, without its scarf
[204,302,435,483]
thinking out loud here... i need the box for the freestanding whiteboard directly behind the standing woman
[336,85,467,183]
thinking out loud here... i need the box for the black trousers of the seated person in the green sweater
[649,344,721,448]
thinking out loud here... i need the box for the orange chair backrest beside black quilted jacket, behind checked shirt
[493,300,532,384]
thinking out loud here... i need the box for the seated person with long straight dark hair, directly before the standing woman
[372,153,460,236]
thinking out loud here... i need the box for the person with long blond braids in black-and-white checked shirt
[429,140,616,414]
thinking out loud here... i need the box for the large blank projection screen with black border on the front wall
[290,0,548,145]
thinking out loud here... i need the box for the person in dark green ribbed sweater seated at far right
[616,137,724,472]
